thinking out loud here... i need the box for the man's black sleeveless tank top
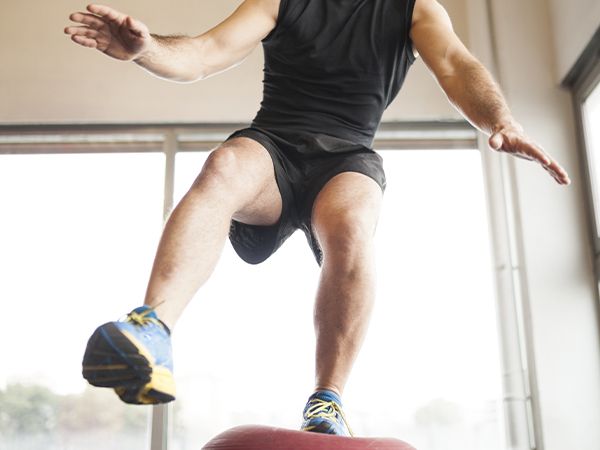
[252,0,415,152]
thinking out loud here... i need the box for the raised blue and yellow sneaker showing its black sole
[82,306,175,405]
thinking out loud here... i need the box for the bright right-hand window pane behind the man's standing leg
[172,150,504,450]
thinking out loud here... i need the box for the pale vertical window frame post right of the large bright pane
[479,136,541,449]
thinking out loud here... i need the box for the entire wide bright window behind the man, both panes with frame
[0,124,507,450]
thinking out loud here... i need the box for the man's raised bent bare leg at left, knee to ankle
[145,137,282,328]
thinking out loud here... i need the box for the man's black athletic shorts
[226,127,386,265]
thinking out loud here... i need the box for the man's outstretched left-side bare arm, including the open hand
[65,0,279,82]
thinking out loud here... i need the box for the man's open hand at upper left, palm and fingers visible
[65,5,152,61]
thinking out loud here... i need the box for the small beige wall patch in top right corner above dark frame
[548,0,600,80]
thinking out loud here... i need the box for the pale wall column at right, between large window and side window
[469,0,600,450]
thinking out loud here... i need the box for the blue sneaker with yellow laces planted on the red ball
[301,391,352,436]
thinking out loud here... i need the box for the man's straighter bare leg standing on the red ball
[312,172,382,394]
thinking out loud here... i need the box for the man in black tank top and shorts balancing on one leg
[65,0,570,435]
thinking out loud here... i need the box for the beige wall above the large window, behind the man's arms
[0,0,467,123]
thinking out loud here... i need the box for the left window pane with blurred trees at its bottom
[0,153,164,450]
